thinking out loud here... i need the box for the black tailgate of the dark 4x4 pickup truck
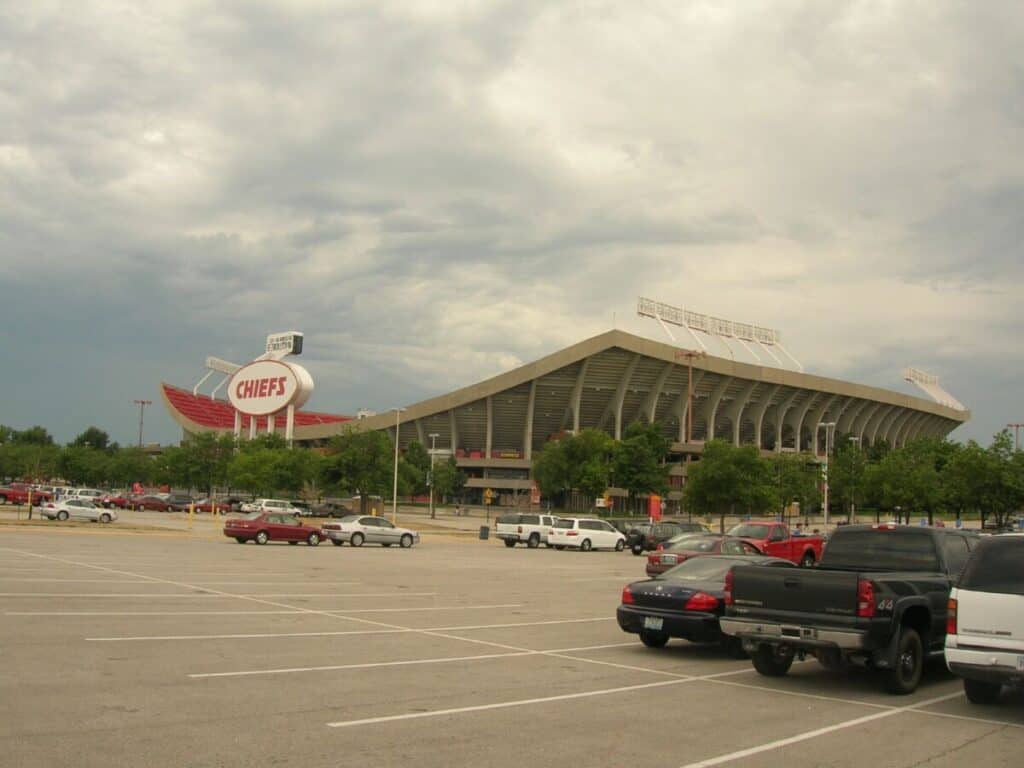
[732,566,858,616]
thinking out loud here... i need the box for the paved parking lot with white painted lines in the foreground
[0,525,1024,768]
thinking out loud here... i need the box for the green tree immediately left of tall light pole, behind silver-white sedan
[321,430,394,514]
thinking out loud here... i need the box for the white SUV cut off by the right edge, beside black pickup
[945,534,1024,705]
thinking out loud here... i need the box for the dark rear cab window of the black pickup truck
[821,527,940,571]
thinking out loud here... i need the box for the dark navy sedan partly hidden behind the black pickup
[616,555,796,658]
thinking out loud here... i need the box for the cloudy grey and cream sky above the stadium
[0,0,1024,443]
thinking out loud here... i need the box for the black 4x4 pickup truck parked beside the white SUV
[721,523,978,694]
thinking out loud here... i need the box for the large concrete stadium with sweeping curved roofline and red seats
[161,305,970,503]
